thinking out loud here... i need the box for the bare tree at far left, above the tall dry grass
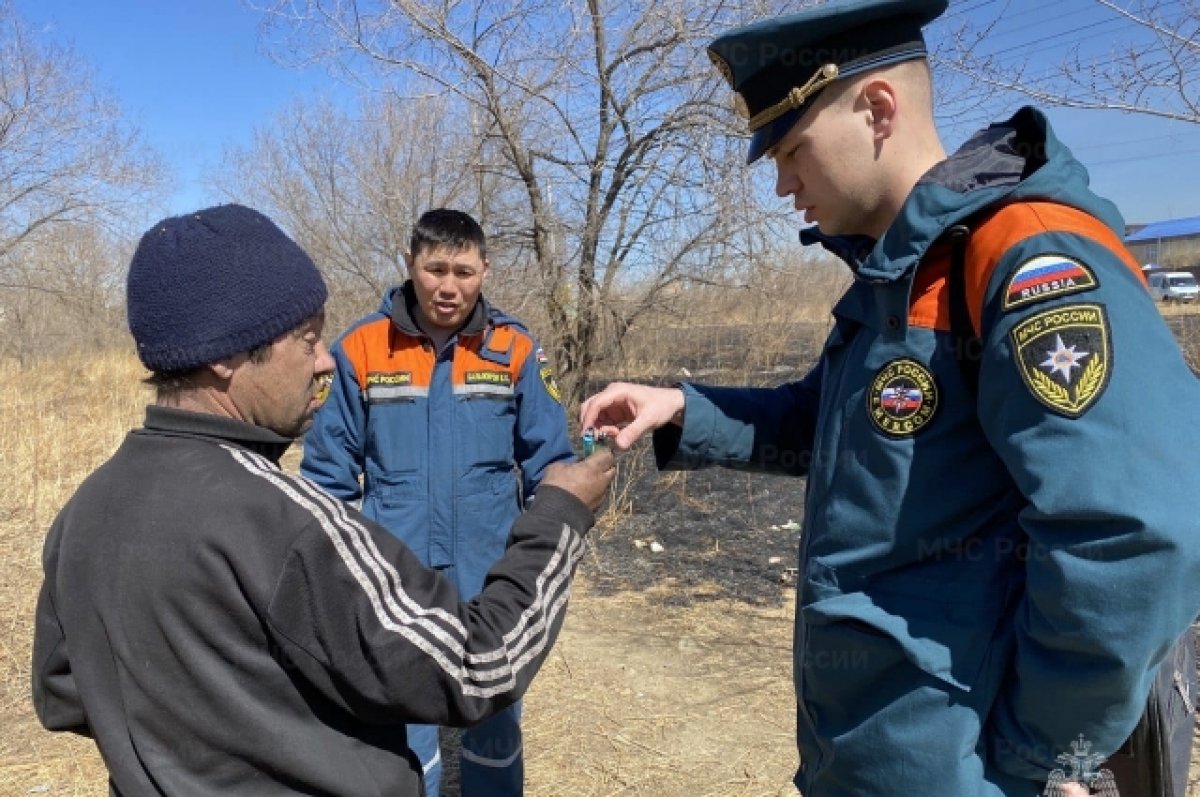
[0,0,162,290]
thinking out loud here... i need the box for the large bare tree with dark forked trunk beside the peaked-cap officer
[254,0,781,402]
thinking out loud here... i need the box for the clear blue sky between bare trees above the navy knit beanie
[16,0,337,216]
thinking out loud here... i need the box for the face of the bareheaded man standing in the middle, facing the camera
[407,246,487,331]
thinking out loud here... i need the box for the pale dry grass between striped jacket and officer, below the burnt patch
[526,583,797,797]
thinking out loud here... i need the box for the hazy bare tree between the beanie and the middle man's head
[215,95,492,322]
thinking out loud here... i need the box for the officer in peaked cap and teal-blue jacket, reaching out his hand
[582,0,1200,797]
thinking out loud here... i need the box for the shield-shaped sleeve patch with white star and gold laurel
[1009,304,1112,418]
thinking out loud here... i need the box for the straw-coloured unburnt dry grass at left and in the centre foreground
[0,297,1200,797]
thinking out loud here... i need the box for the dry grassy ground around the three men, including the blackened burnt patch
[0,317,1200,797]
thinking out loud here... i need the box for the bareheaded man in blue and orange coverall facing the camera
[300,209,572,797]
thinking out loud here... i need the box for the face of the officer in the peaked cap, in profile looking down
[768,89,878,235]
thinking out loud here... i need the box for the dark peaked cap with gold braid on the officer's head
[708,0,947,163]
